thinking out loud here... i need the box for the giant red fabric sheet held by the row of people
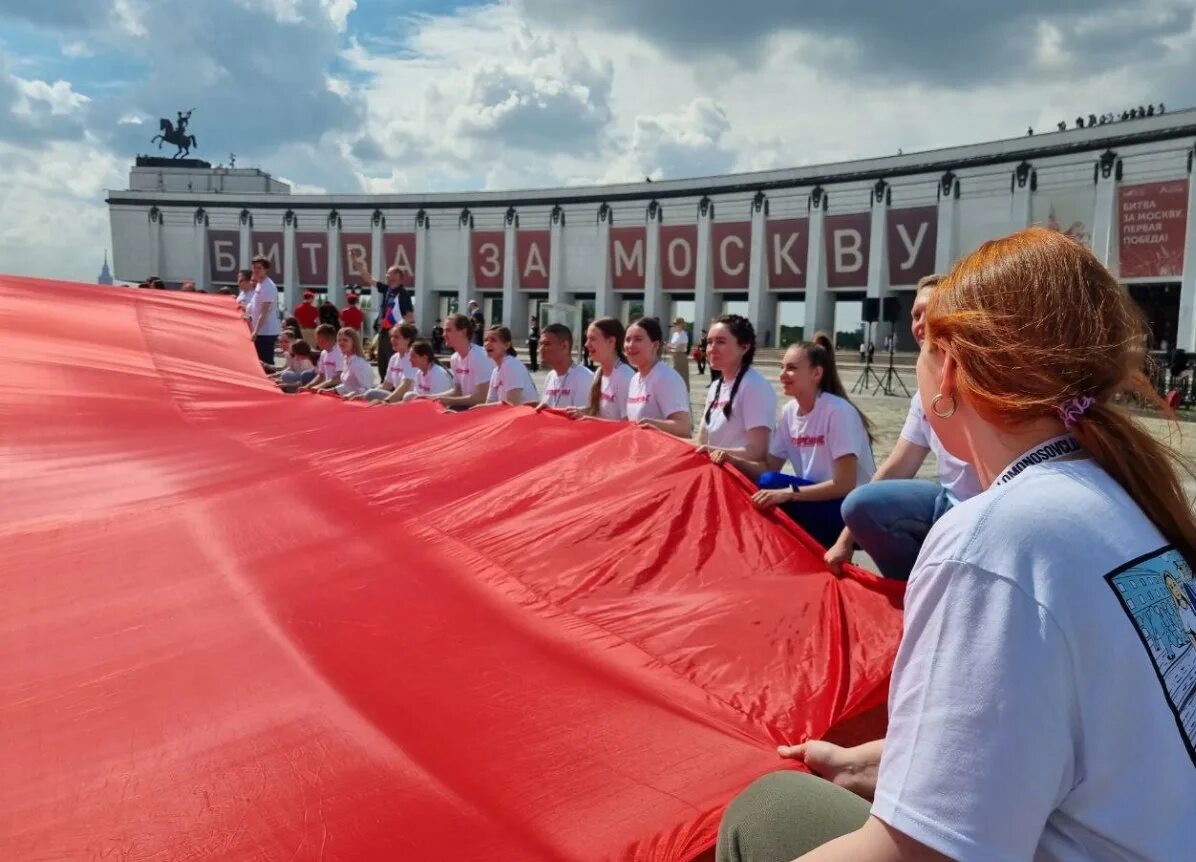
[0,277,901,862]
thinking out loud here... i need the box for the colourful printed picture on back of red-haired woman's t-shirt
[1105,548,1196,765]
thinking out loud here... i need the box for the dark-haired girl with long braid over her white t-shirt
[697,314,776,464]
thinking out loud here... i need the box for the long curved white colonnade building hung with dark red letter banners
[108,110,1196,350]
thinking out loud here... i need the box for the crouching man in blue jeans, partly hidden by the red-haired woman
[825,275,980,581]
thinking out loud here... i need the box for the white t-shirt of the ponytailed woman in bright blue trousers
[768,392,877,485]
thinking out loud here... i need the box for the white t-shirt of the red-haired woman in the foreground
[872,447,1196,862]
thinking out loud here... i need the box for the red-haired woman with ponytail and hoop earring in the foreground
[718,228,1196,862]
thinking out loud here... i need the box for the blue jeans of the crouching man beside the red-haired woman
[843,479,953,581]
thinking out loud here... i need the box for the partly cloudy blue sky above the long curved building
[0,0,1196,279]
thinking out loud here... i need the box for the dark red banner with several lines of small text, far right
[1117,179,1188,279]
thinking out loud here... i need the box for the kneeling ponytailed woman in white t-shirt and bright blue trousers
[712,335,875,548]
